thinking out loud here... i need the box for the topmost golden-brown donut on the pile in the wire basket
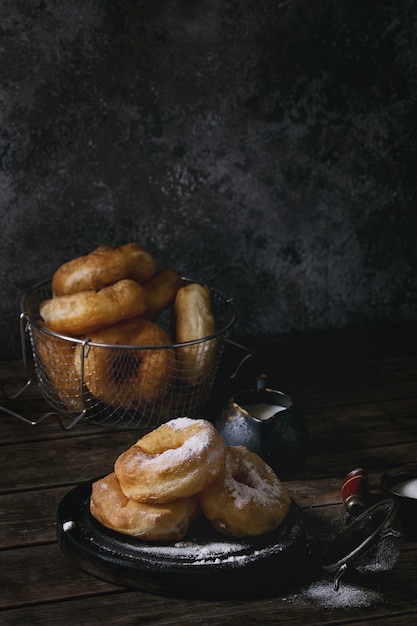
[52,243,156,296]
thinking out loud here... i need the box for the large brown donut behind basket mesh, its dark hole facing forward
[75,317,176,412]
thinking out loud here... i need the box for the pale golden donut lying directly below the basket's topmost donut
[39,279,147,337]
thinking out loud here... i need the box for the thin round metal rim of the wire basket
[20,276,237,350]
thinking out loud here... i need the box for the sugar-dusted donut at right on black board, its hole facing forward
[199,446,291,537]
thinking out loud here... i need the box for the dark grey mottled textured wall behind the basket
[0,0,417,356]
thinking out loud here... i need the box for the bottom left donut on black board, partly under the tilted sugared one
[90,473,199,541]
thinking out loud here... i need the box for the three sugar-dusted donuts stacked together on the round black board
[90,417,291,541]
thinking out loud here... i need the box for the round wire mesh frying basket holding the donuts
[21,278,236,428]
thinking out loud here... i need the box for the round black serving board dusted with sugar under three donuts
[57,481,307,598]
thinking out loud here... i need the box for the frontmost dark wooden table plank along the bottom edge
[1,592,417,626]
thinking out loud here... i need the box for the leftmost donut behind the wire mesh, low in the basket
[31,321,84,413]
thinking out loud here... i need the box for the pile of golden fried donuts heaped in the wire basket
[37,243,215,412]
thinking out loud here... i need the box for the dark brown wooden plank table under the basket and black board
[0,325,417,626]
